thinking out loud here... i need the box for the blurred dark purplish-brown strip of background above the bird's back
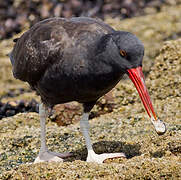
[0,0,181,40]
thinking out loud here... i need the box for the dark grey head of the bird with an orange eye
[98,31,144,73]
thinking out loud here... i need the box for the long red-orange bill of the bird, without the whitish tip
[128,67,157,120]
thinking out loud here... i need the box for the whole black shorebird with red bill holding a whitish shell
[9,17,166,163]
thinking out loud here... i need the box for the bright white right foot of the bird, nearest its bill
[87,151,126,163]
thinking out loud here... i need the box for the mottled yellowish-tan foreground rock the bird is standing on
[0,39,181,179]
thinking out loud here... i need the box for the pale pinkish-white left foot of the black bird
[34,151,72,163]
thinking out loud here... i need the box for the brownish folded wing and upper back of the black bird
[11,18,113,86]
